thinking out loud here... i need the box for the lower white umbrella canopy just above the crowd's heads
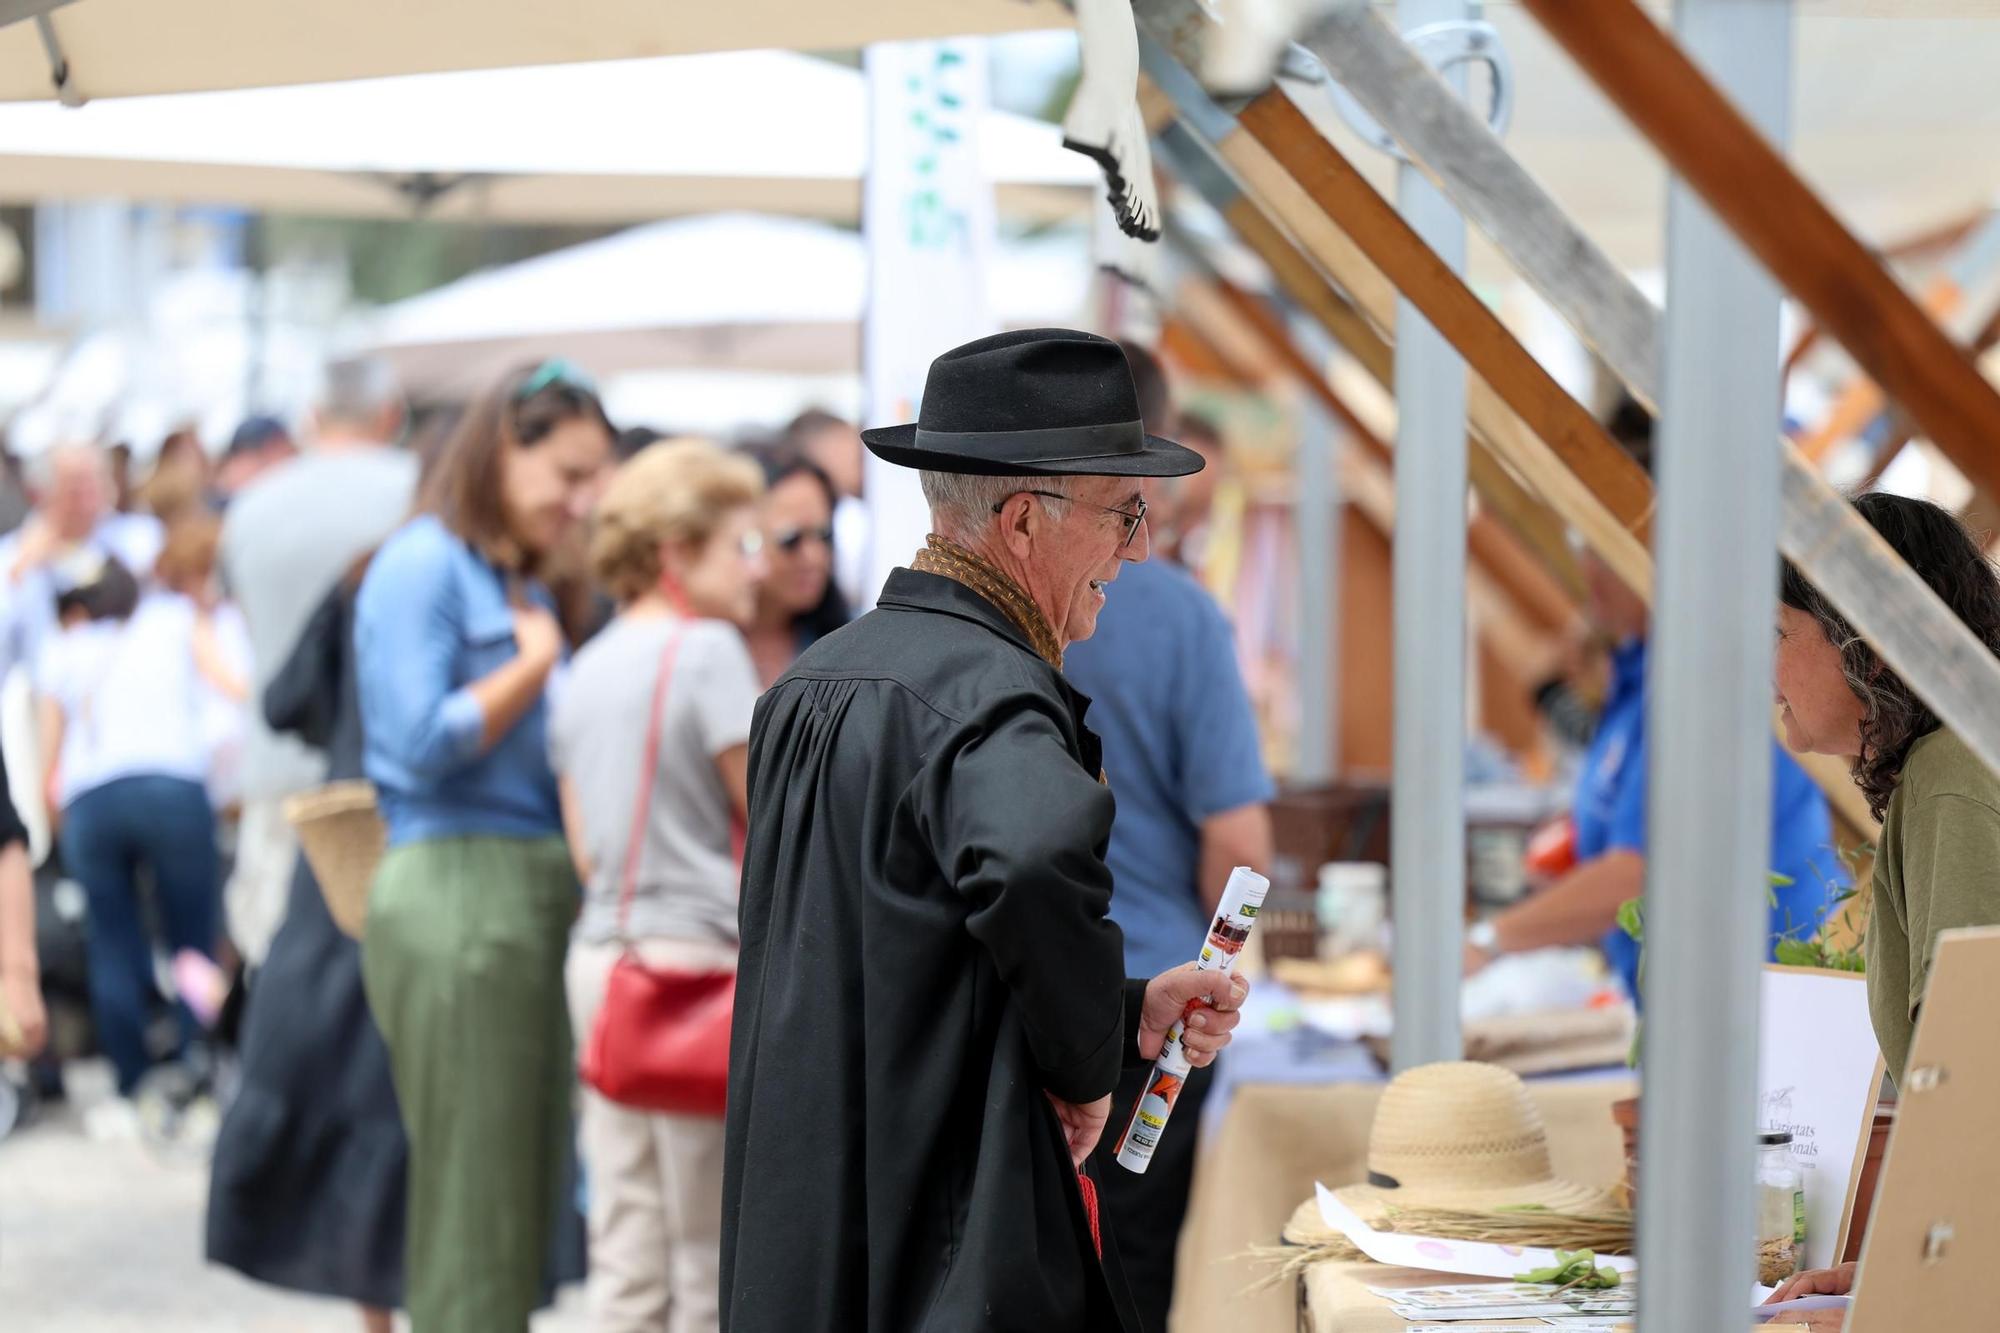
[368,214,1092,398]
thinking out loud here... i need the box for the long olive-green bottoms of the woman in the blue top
[362,837,578,1333]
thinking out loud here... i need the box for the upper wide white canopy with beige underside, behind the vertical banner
[0,50,1102,222]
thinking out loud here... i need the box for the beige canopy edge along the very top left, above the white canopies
[0,0,1070,100]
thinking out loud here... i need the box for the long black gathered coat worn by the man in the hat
[722,570,1144,1333]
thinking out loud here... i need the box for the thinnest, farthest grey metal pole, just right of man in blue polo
[1292,352,1342,783]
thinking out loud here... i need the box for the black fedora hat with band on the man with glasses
[862,328,1202,476]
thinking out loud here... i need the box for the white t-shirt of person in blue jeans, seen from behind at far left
[36,592,250,805]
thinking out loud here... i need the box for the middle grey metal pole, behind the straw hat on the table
[1390,0,1468,1071]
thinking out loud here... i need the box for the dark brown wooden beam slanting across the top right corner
[1524,0,2000,506]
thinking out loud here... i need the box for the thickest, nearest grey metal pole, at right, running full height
[1640,0,1792,1333]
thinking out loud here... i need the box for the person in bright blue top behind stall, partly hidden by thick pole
[1466,404,1846,999]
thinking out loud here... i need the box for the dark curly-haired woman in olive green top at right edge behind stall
[1776,494,2000,1297]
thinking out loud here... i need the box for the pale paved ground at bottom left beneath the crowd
[0,1056,586,1333]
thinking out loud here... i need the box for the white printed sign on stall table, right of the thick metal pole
[1758,967,1882,1269]
